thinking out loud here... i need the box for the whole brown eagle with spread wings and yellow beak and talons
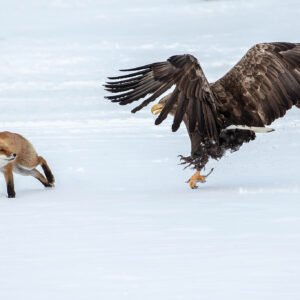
[106,43,300,188]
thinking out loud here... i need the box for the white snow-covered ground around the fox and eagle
[0,0,300,300]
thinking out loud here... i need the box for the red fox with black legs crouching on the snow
[0,131,55,198]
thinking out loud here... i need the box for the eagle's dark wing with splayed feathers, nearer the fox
[105,55,219,141]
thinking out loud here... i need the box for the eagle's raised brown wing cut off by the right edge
[211,43,300,126]
